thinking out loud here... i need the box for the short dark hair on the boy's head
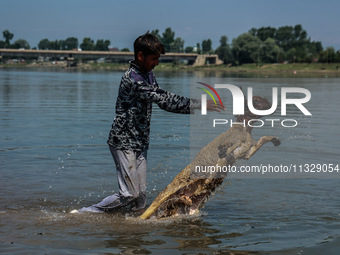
[133,32,165,58]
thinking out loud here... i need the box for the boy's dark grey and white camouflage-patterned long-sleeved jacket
[107,62,201,151]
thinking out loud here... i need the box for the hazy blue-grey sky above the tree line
[0,0,340,50]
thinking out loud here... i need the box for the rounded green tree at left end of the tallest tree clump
[232,33,261,64]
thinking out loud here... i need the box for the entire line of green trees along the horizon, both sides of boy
[0,25,340,65]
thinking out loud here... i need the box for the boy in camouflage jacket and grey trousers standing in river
[79,33,224,212]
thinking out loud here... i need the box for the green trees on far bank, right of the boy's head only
[151,25,340,65]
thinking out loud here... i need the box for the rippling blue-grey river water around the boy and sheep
[0,69,340,254]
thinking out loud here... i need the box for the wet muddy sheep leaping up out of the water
[140,96,280,219]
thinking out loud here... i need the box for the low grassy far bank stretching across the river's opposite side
[0,61,340,77]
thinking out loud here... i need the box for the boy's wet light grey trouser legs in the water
[79,146,147,212]
